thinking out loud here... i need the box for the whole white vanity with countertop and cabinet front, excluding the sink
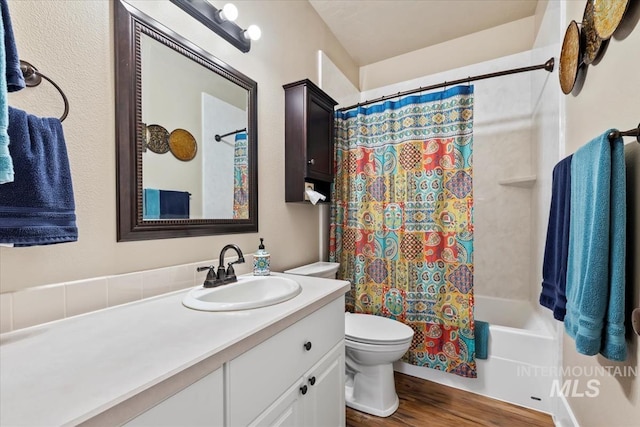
[0,273,350,427]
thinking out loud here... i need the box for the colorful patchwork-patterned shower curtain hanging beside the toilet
[330,86,476,377]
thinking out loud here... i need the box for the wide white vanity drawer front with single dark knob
[229,297,344,426]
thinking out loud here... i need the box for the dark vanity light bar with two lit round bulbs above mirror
[171,0,262,53]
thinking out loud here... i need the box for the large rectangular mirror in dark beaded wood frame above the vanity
[114,0,258,241]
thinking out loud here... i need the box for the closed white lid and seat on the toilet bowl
[345,313,413,344]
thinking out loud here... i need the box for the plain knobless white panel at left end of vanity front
[125,368,224,427]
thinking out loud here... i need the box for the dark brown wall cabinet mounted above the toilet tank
[283,80,337,202]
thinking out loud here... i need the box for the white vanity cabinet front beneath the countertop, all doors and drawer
[126,298,345,427]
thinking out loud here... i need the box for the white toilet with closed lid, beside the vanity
[285,262,413,417]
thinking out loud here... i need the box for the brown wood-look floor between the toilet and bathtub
[347,372,553,427]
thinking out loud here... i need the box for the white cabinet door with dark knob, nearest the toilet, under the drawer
[302,341,345,427]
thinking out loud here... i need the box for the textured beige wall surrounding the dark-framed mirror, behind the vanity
[0,0,358,292]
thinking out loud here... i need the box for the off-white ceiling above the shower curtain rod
[309,0,538,66]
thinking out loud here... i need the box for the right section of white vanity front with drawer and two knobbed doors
[228,298,345,427]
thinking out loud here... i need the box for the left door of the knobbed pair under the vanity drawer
[249,380,304,427]
